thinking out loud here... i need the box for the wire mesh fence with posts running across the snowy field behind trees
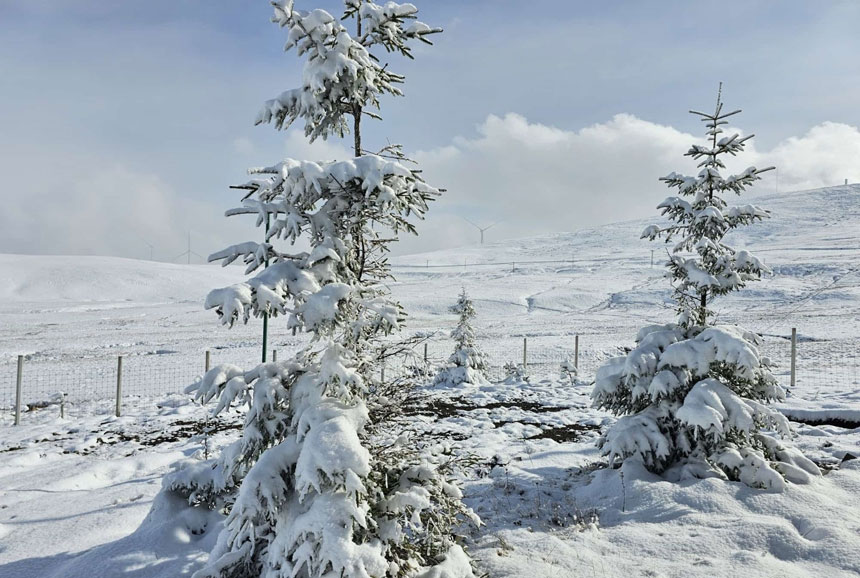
[0,329,860,425]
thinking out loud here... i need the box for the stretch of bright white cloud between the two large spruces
[406,114,694,249]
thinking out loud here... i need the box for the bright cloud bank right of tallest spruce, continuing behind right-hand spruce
[404,114,860,251]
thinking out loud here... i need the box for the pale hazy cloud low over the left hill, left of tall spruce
[0,158,245,262]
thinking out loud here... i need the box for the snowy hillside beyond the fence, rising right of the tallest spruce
[393,184,860,354]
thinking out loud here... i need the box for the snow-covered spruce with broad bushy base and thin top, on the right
[592,91,820,489]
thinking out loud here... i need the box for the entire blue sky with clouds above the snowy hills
[0,0,860,261]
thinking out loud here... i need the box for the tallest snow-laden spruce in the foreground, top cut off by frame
[167,0,473,578]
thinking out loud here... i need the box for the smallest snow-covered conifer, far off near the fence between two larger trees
[436,289,487,386]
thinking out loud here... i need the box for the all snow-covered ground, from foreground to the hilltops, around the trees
[0,185,860,578]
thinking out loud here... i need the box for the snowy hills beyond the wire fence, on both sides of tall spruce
[0,185,860,362]
